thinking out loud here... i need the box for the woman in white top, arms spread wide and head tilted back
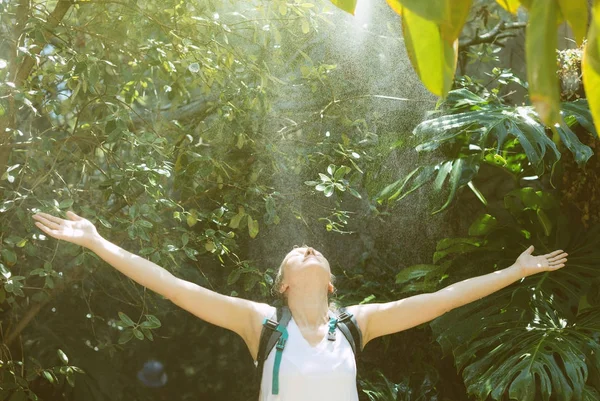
[33,211,567,401]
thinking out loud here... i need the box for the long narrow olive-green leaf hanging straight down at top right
[525,0,564,126]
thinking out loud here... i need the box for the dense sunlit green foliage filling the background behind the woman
[0,0,600,401]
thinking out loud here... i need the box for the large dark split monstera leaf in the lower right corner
[431,286,600,401]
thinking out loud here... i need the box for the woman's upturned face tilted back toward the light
[283,247,331,291]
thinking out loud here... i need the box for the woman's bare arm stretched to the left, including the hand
[33,211,275,357]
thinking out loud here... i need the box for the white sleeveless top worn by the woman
[259,318,358,401]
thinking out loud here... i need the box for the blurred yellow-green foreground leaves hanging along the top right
[332,0,600,135]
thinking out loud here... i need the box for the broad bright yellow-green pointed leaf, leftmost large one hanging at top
[402,4,458,98]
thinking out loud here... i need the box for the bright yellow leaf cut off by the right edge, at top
[581,1,600,137]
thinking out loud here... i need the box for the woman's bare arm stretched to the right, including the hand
[348,246,567,344]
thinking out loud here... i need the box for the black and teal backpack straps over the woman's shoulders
[256,306,362,399]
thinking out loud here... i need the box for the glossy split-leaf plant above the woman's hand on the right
[376,73,596,213]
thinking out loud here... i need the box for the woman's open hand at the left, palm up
[33,211,100,248]
